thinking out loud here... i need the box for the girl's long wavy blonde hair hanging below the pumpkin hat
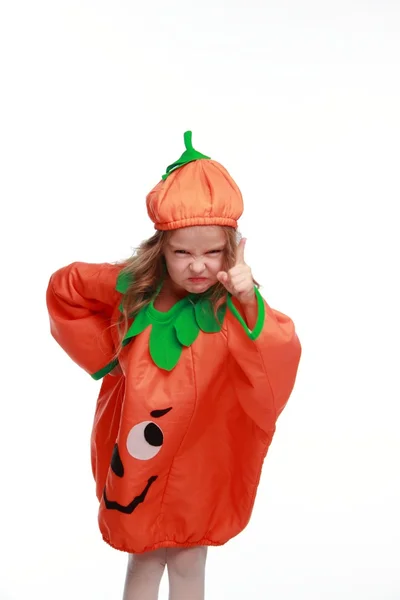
[115,227,241,339]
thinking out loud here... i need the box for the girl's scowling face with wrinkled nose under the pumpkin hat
[164,225,226,294]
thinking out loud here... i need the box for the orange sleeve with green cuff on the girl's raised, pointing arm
[227,290,301,431]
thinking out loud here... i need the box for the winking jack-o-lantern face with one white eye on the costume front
[103,407,172,515]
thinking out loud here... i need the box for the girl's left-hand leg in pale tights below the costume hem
[123,548,166,600]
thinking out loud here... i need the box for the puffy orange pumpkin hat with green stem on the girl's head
[146,131,243,231]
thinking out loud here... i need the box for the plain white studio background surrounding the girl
[0,0,400,600]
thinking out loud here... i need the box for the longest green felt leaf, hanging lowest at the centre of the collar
[149,322,182,371]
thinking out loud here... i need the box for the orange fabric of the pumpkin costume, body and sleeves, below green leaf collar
[48,263,301,553]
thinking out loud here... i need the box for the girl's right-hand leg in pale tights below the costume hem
[167,546,207,600]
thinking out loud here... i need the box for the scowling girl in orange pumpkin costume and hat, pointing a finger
[47,132,301,600]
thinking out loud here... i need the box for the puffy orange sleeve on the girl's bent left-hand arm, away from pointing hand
[46,262,121,379]
